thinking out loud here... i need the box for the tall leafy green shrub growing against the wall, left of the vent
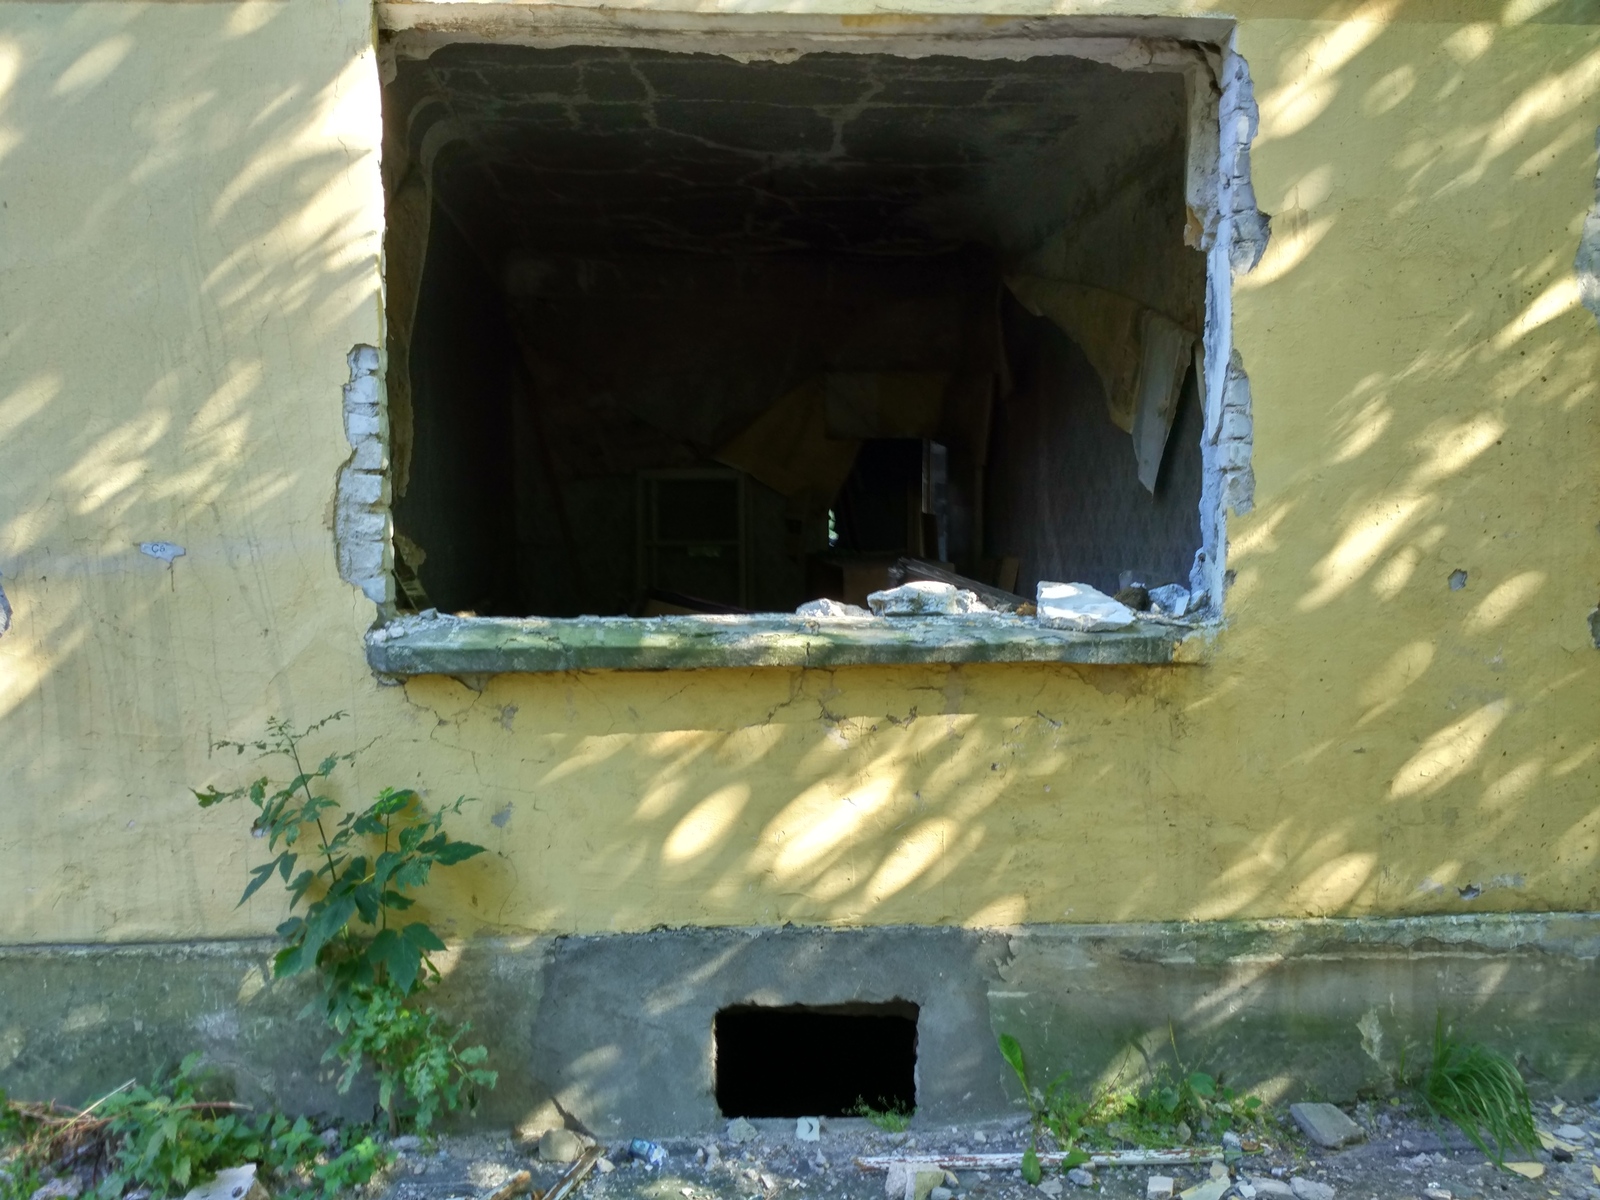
[195,714,496,1131]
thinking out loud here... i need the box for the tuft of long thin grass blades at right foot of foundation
[1418,1013,1539,1166]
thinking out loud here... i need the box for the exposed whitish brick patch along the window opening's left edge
[333,344,392,606]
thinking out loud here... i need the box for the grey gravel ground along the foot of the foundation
[371,1104,1600,1200]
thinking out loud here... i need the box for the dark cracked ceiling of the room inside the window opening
[386,43,1186,259]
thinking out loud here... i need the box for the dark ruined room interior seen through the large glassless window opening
[384,43,1205,616]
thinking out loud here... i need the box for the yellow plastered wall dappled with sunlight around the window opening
[0,0,1600,942]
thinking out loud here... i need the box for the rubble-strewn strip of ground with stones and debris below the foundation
[363,1102,1600,1200]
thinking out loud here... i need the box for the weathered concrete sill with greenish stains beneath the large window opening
[366,614,1210,675]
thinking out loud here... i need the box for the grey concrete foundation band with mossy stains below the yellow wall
[0,914,1600,1136]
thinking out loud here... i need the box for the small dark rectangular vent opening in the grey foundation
[712,1000,918,1117]
